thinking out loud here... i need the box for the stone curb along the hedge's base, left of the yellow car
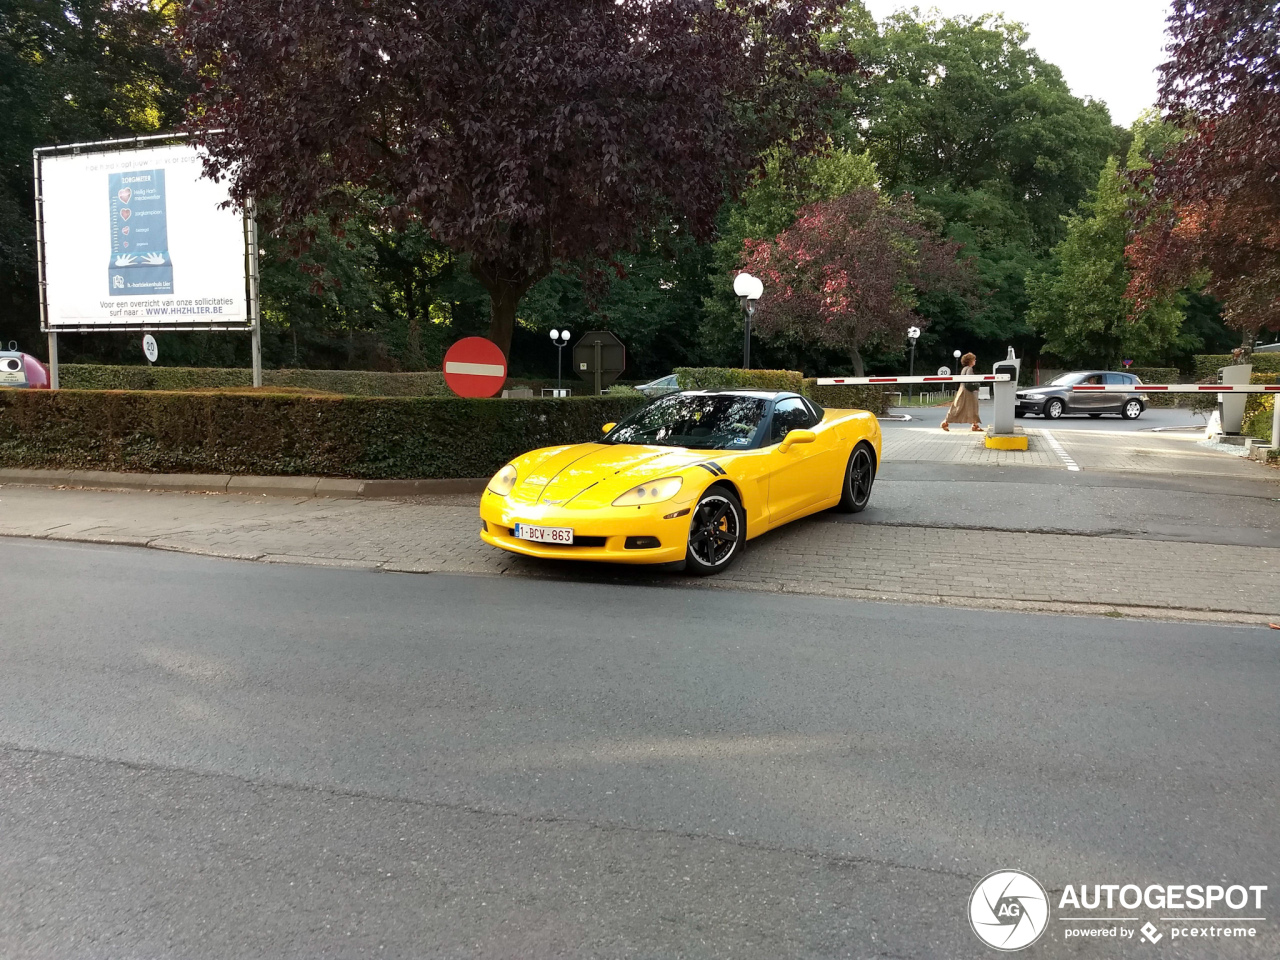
[0,467,488,499]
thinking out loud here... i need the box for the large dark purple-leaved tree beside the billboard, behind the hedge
[179,0,852,352]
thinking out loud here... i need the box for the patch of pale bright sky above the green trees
[863,0,1170,127]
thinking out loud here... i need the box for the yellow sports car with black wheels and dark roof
[480,390,881,573]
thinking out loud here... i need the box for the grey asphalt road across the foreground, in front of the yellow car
[0,540,1280,960]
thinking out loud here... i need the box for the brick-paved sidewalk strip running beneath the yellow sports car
[0,485,1280,623]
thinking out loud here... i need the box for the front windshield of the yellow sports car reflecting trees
[604,393,765,451]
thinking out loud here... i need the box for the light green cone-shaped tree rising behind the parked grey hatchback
[1028,157,1185,369]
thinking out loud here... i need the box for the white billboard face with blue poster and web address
[37,143,252,330]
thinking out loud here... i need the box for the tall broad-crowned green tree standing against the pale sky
[838,5,1126,371]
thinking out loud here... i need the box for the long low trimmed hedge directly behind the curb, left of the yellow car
[0,390,644,480]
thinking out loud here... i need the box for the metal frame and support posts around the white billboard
[32,131,262,389]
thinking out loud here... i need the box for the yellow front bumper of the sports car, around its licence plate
[480,490,691,563]
